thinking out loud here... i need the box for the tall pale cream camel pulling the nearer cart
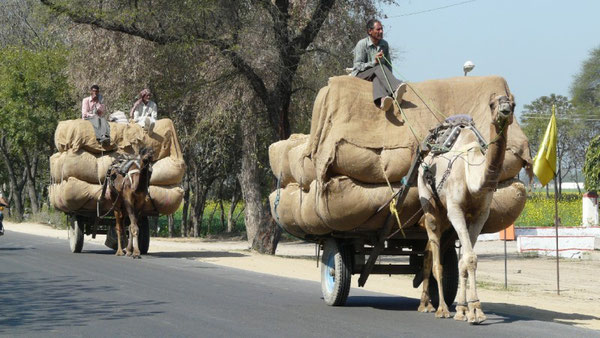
[418,94,515,324]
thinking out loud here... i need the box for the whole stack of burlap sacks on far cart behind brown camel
[49,119,185,215]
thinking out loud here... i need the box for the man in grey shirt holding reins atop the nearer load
[351,19,406,111]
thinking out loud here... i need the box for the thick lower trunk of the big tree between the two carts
[239,117,279,254]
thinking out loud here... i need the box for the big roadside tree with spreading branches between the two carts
[40,0,391,253]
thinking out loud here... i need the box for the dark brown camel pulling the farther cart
[107,148,154,258]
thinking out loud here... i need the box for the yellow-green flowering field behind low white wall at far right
[515,192,582,227]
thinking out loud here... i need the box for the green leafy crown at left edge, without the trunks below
[0,47,73,151]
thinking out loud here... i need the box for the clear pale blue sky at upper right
[381,0,600,116]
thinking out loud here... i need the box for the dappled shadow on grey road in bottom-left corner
[0,273,166,334]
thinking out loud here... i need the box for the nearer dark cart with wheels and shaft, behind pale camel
[310,146,458,307]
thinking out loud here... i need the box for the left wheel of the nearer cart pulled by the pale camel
[321,239,352,306]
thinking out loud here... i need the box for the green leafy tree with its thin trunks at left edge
[0,47,73,219]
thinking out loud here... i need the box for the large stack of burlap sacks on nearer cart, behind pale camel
[269,76,531,238]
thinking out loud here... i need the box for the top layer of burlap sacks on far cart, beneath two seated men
[54,119,183,160]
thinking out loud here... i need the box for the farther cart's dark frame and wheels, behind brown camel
[66,211,158,255]
